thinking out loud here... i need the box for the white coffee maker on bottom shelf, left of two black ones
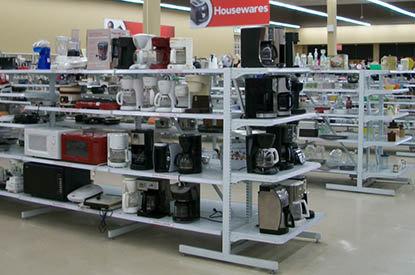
[122,176,141,214]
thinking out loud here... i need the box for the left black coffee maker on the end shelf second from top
[245,77,277,118]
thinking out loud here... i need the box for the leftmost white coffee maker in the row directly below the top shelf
[116,77,144,111]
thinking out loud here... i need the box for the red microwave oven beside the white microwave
[62,130,107,165]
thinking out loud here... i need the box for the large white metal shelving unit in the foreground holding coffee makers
[0,68,324,271]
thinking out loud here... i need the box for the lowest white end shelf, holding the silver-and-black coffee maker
[231,213,325,245]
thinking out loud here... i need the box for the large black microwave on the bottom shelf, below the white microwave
[23,162,91,201]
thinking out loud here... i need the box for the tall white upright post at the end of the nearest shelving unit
[222,68,232,255]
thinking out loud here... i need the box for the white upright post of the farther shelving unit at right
[357,71,369,189]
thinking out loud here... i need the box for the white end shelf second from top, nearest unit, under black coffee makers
[232,113,316,130]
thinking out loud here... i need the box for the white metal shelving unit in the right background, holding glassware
[299,71,412,196]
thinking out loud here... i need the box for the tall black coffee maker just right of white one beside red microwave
[131,129,154,170]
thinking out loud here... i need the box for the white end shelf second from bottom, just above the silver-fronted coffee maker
[231,162,321,183]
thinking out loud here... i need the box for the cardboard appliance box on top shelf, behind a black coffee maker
[87,29,130,70]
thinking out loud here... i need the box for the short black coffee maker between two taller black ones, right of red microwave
[154,143,182,173]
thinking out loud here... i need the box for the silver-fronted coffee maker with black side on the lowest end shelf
[258,183,295,235]
